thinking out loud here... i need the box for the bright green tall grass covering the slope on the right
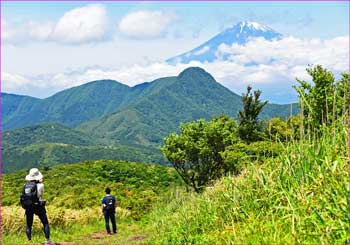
[149,119,350,244]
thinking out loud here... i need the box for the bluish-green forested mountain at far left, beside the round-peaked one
[2,80,131,129]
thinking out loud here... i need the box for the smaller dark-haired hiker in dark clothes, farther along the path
[102,187,117,234]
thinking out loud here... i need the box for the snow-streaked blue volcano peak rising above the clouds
[166,21,282,64]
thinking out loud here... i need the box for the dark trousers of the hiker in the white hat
[26,205,50,240]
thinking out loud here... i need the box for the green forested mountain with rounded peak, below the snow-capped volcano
[78,68,297,145]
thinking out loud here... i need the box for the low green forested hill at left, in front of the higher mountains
[2,123,167,173]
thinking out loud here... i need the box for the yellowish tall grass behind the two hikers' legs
[1,206,130,244]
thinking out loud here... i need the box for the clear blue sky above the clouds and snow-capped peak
[2,1,349,38]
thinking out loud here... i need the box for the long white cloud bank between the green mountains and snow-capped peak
[3,34,349,103]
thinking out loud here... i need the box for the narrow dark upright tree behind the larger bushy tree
[238,86,268,144]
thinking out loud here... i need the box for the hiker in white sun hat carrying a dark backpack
[21,168,51,244]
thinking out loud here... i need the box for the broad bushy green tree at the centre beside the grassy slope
[161,115,239,192]
